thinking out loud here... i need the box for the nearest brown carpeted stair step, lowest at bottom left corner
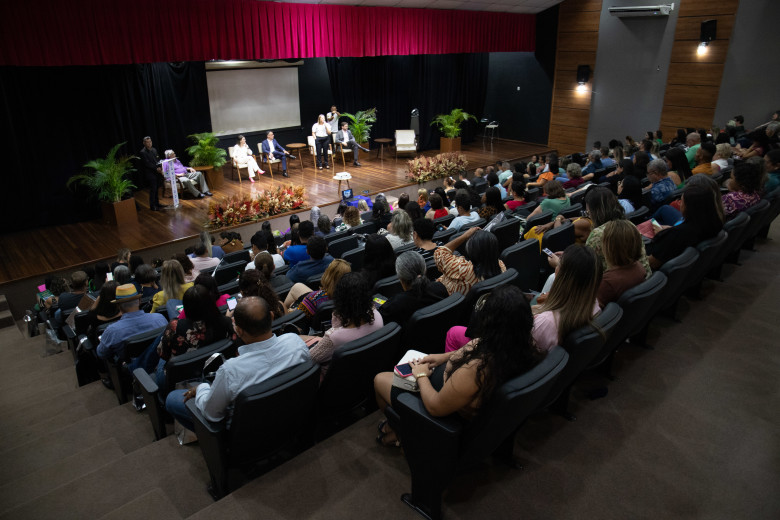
[0,436,213,520]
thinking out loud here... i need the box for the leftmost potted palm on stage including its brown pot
[67,143,138,227]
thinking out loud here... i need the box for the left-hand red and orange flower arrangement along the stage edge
[206,184,306,229]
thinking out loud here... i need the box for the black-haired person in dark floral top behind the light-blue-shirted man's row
[157,284,233,368]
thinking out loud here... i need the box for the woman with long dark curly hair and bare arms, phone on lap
[374,285,546,446]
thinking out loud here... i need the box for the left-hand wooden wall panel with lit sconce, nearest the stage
[547,0,602,155]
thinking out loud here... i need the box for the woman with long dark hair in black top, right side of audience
[648,185,723,269]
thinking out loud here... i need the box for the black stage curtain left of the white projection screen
[0,62,211,233]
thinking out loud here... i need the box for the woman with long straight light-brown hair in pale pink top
[533,244,602,351]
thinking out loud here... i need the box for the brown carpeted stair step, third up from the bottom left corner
[0,402,154,484]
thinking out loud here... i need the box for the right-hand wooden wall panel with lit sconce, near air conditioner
[659,0,739,139]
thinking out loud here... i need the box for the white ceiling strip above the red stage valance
[274,0,563,13]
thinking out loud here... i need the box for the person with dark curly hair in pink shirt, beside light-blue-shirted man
[303,273,384,381]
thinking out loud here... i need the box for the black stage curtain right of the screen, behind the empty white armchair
[326,53,489,150]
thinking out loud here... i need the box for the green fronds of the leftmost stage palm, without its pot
[67,143,137,203]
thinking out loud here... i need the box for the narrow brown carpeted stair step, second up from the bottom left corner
[0,439,125,513]
